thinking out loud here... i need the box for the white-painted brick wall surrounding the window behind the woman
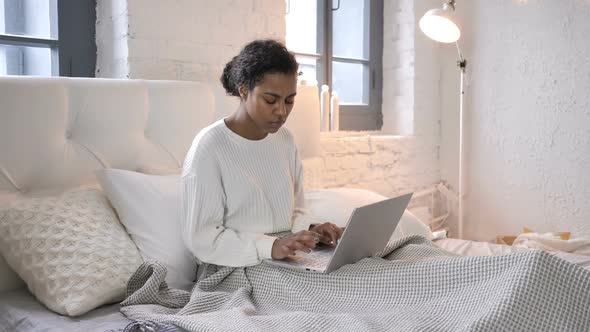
[97,0,440,215]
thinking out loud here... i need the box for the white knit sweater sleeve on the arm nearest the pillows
[181,156,276,266]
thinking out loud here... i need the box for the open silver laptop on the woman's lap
[266,193,412,273]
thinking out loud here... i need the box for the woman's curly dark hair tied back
[220,39,299,97]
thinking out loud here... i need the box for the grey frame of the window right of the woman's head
[286,0,383,130]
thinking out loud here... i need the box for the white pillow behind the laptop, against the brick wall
[305,188,432,239]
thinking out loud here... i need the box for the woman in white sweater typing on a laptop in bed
[182,40,342,267]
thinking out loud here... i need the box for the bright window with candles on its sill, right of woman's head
[286,0,383,130]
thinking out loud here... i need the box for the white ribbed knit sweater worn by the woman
[181,119,321,266]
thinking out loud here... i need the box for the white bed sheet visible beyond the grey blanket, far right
[434,239,590,270]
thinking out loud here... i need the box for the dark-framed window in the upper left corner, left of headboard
[0,0,96,77]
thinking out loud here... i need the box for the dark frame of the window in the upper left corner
[0,0,96,77]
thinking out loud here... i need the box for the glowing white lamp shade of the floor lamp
[419,9,461,43]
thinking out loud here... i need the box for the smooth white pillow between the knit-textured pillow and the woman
[96,169,197,290]
